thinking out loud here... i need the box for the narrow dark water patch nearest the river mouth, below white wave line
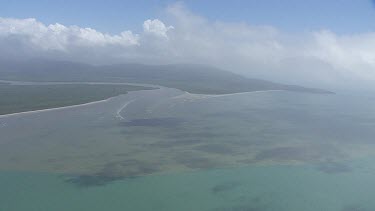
[120,118,184,127]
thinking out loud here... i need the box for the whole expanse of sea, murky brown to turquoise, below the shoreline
[0,88,375,211]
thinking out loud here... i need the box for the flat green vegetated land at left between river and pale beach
[0,84,151,115]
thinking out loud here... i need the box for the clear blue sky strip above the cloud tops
[0,0,375,34]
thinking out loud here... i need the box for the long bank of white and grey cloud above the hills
[0,4,375,89]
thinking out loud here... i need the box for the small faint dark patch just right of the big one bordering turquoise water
[176,153,220,169]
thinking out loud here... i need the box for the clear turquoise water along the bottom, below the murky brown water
[0,161,375,211]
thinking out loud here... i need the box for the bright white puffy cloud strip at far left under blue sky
[0,18,139,51]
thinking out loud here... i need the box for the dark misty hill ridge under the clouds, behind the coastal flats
[0,60,332,94]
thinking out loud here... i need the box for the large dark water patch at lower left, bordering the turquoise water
[65,159,160,187]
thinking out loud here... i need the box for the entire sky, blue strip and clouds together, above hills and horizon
[0,0,375,87]
